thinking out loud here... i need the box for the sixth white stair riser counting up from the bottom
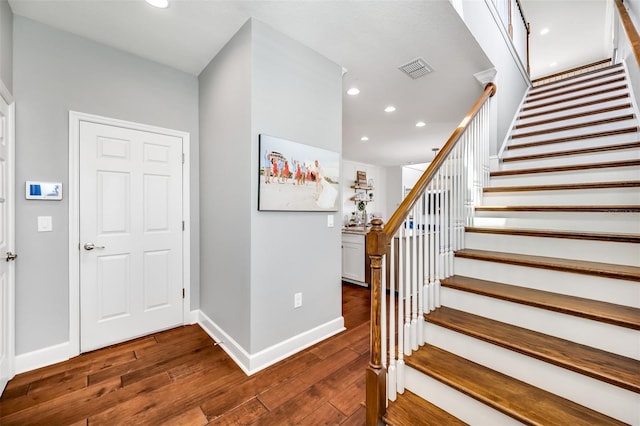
[473,212,640,234]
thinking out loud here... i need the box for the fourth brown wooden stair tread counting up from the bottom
[442,275,640,332]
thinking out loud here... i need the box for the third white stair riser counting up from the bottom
[440,287,640,359]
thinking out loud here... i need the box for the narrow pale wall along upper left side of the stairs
[462,0,530,155]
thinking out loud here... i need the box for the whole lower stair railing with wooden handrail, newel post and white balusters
[366,83,496,425]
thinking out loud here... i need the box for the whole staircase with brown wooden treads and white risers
[385,65,640,425]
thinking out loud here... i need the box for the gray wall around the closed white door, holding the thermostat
[13,16,199,355]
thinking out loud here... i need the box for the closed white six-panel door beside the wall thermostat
[80,121,183,352]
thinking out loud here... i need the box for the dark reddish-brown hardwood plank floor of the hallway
[0,284,369,426]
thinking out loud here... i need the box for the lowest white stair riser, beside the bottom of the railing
[405,367,522,426]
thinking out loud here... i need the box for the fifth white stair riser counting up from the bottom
[465,232,640,264]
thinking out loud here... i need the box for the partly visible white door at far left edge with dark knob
[0,92,16,394]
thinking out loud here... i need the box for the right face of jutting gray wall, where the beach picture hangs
[250,21,342,353]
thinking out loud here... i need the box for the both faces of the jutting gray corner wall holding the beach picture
[200,20,342,354]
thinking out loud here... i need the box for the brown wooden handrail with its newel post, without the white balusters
[365,83,496,426]
